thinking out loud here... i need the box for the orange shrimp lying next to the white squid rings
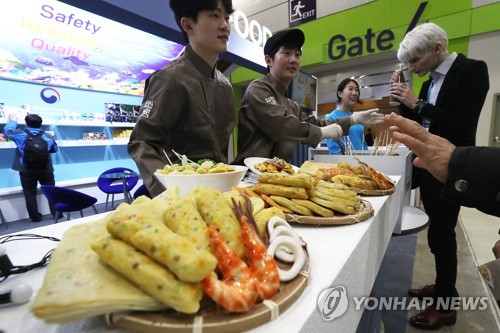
[233,197,280,300]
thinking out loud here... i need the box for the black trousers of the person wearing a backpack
[19,171,56,221]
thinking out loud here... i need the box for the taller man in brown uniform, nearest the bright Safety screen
[128,0,234,196]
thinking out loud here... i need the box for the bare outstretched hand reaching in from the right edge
[385,113,455,182]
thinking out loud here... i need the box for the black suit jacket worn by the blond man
[401,54,489,146]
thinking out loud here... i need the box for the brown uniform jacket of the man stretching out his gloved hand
[235,74,350,164]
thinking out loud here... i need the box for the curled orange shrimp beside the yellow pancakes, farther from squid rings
[200,226,258,312]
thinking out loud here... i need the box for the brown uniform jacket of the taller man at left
[128,46,235,196]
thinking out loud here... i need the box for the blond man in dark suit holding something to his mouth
[391,23,489,330]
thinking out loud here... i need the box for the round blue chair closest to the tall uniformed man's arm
[97,167,139,210]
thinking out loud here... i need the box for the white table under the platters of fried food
[0,176,404,333]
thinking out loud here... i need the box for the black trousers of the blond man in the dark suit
[419,170,460,297]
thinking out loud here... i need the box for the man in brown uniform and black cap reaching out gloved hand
[235,29,384,164]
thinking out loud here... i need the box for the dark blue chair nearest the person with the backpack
[40,185,97,223]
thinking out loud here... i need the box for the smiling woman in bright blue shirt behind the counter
[325,78,384,154]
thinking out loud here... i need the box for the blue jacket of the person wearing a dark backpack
[4,120,59,172]
